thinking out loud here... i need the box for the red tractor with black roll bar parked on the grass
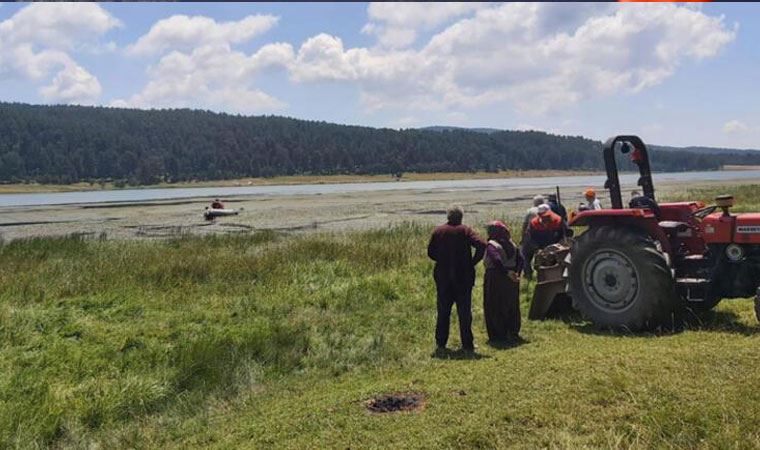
[530,136,760,330]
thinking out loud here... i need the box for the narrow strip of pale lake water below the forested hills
[0,170,760,207]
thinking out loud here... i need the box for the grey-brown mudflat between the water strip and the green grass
[0,180,748,240]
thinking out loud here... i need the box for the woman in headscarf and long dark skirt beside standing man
[483,220,523,342]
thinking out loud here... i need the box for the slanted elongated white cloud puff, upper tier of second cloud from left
[127,15,278,55]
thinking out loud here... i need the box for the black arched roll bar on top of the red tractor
[602,136,655,209]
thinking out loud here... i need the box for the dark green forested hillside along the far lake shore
[0,103,760,184]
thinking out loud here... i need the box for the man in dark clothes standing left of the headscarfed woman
[428,207,486,351]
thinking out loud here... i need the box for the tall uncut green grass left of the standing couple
[0,225,436,447]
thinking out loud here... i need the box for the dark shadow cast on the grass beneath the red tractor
[563,309,760,337]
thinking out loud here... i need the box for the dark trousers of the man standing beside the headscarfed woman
[435,280,474,349]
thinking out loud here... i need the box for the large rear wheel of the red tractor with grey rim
[568,226,679,331]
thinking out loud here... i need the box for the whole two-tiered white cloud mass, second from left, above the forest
[119,15,295,114]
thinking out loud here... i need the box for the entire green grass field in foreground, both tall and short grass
[0,186,760,448]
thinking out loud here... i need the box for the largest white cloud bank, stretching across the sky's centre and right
[291,3,736,114]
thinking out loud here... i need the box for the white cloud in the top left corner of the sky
[0,3,121,103]
